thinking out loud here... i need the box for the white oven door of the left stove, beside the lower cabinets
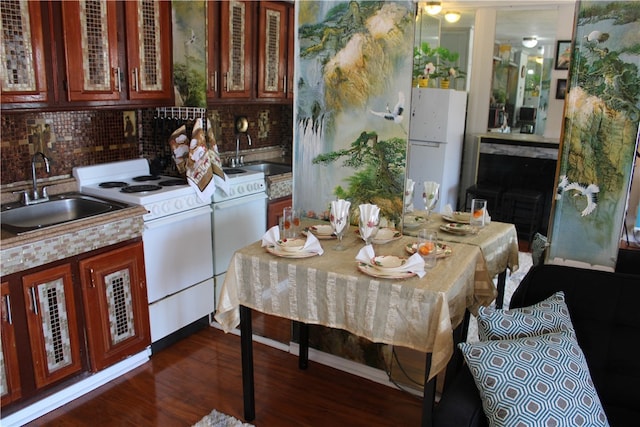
[142,205,213,304]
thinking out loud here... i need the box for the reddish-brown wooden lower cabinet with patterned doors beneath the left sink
[0,239,151,412]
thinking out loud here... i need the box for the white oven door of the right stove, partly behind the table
[212,193,267,276]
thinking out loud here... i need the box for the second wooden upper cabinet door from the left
[62,0,123,101]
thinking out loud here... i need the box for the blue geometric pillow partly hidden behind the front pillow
[477,291,573,341]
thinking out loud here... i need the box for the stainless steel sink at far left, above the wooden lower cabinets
[0,193,130,234]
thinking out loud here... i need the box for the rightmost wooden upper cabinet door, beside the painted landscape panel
[258,1,289,98]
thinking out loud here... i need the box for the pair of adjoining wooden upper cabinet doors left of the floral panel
[62,0,173,104]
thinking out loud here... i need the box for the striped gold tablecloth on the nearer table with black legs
[215,228,496,378]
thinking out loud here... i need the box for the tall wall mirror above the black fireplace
[488,8,558,135]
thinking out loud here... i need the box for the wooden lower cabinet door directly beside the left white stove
[79,243,151,372]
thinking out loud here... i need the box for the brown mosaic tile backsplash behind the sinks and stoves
[0,105,293,185]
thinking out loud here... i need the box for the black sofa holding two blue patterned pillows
[433,265,640,427]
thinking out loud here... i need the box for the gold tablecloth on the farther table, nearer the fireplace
[402,211,518,277]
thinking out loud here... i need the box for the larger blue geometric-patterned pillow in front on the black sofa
[458,332,609,427]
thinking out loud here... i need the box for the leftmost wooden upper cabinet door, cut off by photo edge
[0,0,48,104]
